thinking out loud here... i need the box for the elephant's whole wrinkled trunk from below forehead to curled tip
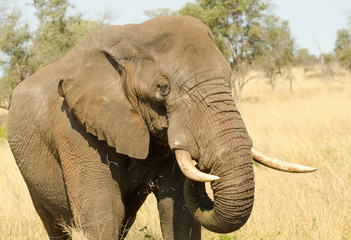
[168,70,254,233]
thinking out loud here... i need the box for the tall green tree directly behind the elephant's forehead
[179,0,268,101]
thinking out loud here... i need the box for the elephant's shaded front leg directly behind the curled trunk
[155,159,201,240]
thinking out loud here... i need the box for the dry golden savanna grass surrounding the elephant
[0,68,351,240]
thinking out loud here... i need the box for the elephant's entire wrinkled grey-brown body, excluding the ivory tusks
[8,17,254,240]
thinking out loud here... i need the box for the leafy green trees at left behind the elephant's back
[0,0,110,107]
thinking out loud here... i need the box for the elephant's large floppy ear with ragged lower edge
[58,25,150,159]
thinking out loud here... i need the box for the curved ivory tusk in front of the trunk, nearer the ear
[174,150,219,182]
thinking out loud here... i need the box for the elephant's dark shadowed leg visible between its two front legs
[120,191,149,239]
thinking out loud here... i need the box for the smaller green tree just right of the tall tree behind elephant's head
[255,14,295,91]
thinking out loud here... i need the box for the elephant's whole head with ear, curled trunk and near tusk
[58,17,316,232]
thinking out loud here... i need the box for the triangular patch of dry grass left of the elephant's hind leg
[0,141,47,240]
